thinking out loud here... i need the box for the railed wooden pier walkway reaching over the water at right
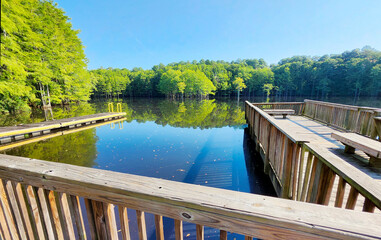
[246,100,381,217]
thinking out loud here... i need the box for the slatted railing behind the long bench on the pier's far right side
[303,100,381,137]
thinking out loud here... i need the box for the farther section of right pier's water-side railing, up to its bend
[245,102,305,197]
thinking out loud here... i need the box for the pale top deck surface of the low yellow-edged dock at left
[0,112,126,138]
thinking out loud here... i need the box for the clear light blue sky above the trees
[56,0,381,69]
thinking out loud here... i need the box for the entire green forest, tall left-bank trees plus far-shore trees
[0,0,381,113]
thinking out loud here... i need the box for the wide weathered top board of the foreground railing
[0,155,381,239]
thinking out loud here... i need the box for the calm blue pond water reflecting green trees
[3,99,280,239]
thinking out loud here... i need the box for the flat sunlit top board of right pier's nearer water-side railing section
[304,143,381,209]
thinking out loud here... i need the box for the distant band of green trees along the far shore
[91,47,381,101]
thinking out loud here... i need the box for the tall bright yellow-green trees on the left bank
[0,0,94,112]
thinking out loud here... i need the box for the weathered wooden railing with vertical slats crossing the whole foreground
[0,155,381,240]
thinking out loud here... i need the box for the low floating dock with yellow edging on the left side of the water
[0,112,126,144]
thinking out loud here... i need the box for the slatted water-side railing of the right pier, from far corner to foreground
[246,102,381,212]
